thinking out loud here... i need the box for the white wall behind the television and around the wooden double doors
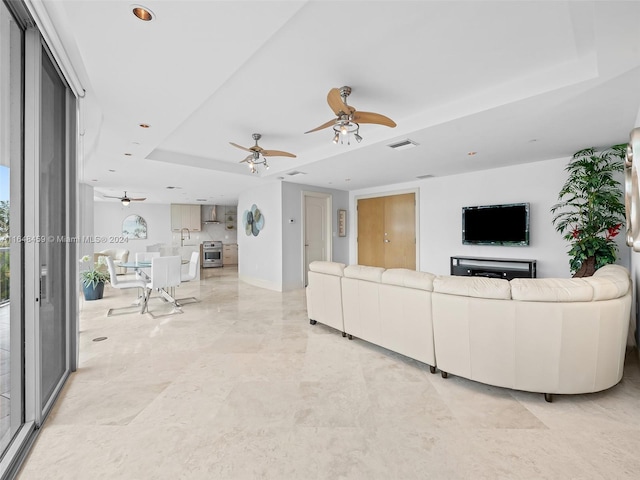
[350,158,629,277]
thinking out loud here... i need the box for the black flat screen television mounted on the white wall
[462,203,529,246]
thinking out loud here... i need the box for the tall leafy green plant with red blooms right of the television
[551,144,627,277]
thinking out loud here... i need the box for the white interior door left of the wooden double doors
[303,192,331,285]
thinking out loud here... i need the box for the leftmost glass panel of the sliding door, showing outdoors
[0,3,24,464]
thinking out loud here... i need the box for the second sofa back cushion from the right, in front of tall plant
[510,278,593,302]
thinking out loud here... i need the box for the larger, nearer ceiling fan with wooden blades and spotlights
[304,86,396,144]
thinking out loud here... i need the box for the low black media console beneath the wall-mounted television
[451,257,536,280]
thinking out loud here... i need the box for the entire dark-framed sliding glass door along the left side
[0,0,78,479]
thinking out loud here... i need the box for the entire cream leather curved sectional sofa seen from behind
[307,262,631,401]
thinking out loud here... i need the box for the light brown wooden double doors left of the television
[358,193,416,270]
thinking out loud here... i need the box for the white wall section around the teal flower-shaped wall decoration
[238,182,283,291]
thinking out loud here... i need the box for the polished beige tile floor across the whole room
[18,268,640,480]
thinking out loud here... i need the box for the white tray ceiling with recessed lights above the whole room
[37,0,640,204]
